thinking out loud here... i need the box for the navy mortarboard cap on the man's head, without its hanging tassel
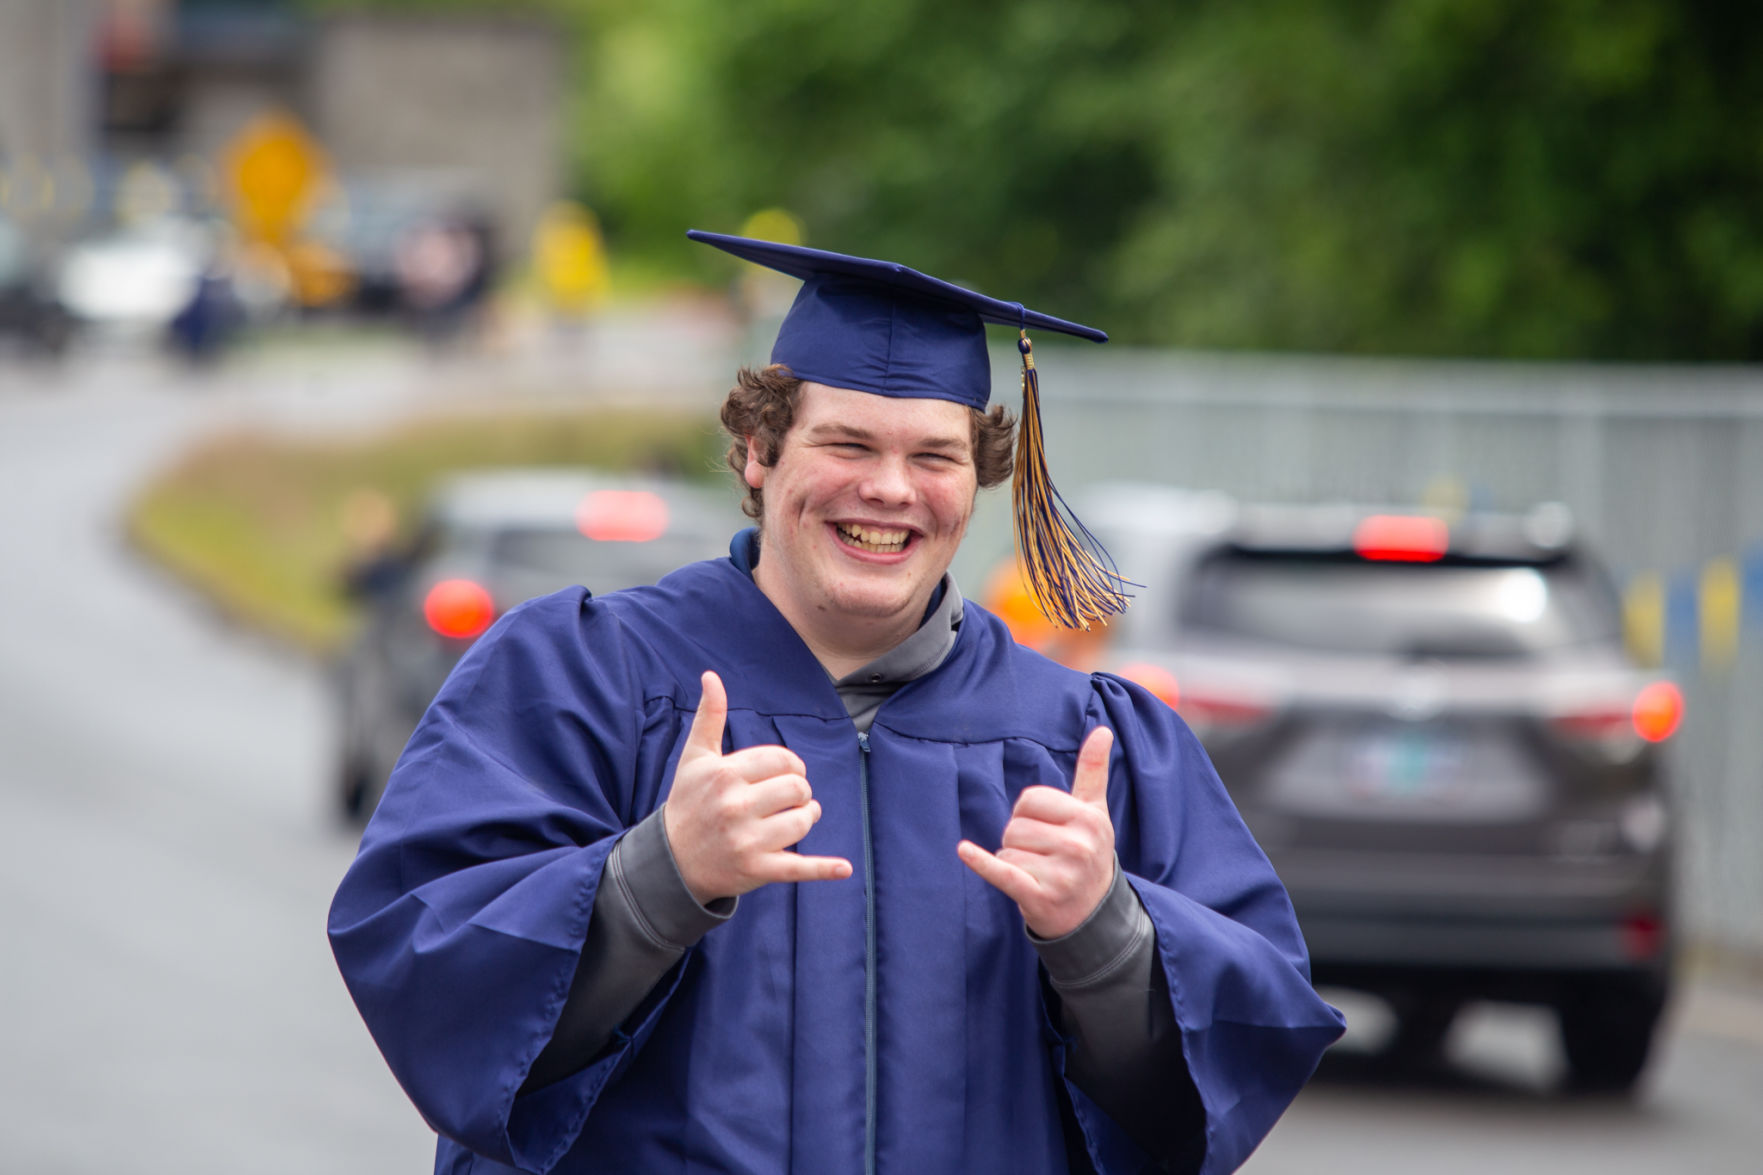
[686,229,1107,408]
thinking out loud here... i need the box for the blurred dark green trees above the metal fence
[307,0,1763,360]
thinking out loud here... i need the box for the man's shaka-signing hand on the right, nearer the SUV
[956,727,1114,939]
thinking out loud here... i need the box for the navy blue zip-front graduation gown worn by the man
[330,559,1340,1175]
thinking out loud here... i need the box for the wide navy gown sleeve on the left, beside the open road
[330,589,681,1171]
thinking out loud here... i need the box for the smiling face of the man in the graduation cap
[746,383,978,672]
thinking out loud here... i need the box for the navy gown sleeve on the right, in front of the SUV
[1067,674,1343,1175]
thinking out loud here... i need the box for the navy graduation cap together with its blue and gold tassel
[686,229,1134,628]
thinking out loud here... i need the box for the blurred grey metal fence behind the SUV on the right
[980,348,1763,956]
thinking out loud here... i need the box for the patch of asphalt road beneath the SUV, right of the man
[1243,976,1763,1175]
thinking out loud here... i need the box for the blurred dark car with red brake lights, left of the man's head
[335,469,740,819]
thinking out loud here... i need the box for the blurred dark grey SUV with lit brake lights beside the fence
[1043,485,1682,1090]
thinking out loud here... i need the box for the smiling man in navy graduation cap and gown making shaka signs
[330,233,1340,1175]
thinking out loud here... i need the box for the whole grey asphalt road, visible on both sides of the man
[0,340,1763,1175]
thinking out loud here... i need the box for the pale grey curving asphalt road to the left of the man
[0,344,432,1175]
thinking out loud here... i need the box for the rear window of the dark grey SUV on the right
[1181,549,1620,660]
